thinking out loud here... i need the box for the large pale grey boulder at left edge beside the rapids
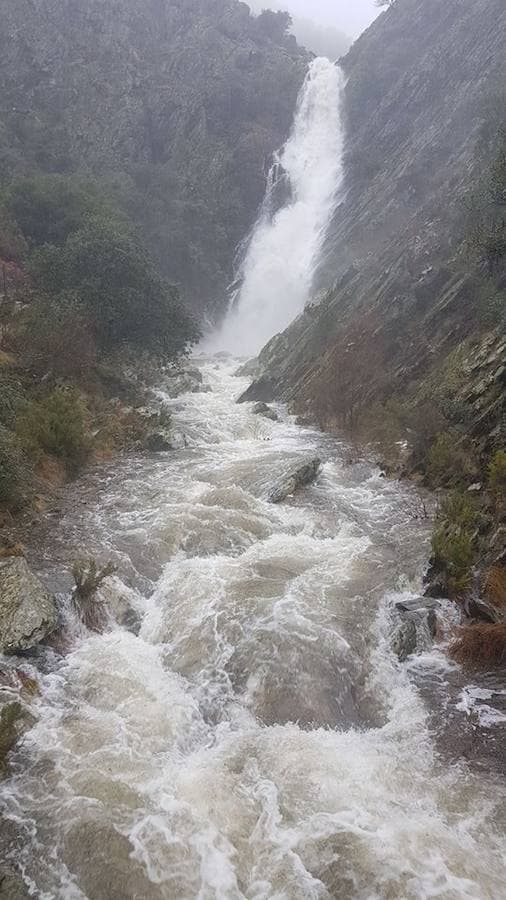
[0,556,58,653]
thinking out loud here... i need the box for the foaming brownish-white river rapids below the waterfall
[1,360,506,900]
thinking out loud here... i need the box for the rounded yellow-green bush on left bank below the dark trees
[17,388,90,470]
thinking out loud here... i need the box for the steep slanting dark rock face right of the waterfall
[247,0,506,426]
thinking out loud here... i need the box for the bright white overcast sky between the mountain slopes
[248,0,380,38]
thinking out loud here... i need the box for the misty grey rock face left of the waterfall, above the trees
[0,0,308,311]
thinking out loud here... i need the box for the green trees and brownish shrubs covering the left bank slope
[0,175,198,528]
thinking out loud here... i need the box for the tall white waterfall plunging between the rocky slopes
[211,58,343,355]
